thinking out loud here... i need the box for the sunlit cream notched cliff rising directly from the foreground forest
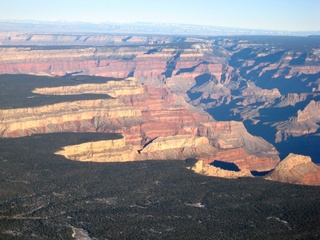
[55,135,216,162]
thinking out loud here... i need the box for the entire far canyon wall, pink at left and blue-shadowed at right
[0,35,320,132]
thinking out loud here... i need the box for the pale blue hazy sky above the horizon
[0,0,320,31]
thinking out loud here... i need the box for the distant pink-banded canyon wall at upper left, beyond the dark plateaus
[0,46,210,80]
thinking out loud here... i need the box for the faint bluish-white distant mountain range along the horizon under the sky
[0,20,320,36]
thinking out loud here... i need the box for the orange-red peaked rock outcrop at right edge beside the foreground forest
[267,153,320,186]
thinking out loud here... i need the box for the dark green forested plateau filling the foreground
[0,133,320,239]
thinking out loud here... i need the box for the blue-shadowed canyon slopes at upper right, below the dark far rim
[219,37,320,79]
